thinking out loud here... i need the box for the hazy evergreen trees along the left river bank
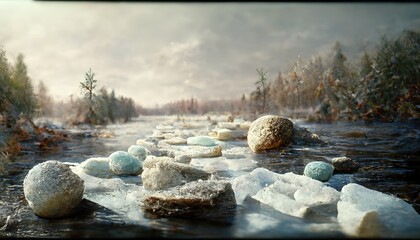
[0,48,138,131]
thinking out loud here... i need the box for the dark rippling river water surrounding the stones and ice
[0,116,420,238]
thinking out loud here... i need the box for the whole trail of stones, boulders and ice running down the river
[24,115,420,237]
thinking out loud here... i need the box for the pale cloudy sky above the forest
[0,0,420,107]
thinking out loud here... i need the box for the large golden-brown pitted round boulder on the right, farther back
[247,115,293,153]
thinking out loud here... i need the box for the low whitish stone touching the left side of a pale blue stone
[78,157,115,178]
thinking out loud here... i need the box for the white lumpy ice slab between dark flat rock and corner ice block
[236,172,340,218]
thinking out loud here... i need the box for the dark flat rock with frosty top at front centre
[143,180,236,219]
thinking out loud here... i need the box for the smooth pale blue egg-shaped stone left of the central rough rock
[109,151,143,175]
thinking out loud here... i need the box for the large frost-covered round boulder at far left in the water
[23,160,85,218]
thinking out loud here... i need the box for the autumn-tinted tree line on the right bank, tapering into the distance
[146,30,420,122]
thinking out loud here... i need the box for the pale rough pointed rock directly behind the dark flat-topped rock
[141,156,210,190]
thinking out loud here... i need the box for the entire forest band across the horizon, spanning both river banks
[0,30,420,129]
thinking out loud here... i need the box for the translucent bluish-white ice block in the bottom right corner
[337,183,420,238]
